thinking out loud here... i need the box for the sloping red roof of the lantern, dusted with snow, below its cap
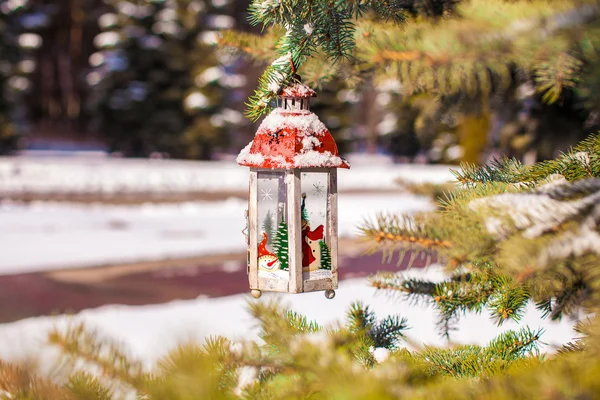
[236,106,350,169]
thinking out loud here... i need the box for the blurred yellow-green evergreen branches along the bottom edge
[0,302,584,400]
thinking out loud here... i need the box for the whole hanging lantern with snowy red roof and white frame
[237,80,350,299]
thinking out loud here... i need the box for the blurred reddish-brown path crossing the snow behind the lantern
[0,241,436,323]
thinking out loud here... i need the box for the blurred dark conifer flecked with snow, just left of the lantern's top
[87,0,243,159]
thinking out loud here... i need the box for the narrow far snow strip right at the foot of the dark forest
[0,157,453,194]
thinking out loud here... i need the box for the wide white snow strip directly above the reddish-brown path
[0,194,432,274]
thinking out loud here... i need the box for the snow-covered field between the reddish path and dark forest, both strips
[0,157,452,274]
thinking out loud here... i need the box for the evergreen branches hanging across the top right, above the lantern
[221,0,599,123]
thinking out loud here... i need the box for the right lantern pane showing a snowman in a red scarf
[300,172,331,280]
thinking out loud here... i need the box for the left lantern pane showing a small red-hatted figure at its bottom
[256,171,289,280]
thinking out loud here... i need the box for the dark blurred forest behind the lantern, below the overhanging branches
[0,0,598,163]
